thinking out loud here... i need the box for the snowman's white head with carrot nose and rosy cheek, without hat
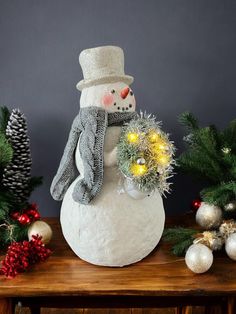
[80,82,136,112]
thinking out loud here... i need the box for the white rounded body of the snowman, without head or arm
[61,127,165,266]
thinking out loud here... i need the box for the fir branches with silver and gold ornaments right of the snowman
[164,113,236,273]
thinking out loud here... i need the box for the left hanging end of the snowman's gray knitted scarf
[50,115,81,201]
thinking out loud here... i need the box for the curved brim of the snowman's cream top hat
[76,75,134,91]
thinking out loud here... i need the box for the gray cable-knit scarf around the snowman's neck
[50,106,136,205]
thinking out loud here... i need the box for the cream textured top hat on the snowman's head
[76,46,134,91]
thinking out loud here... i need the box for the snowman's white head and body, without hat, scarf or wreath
[60,82,165,266]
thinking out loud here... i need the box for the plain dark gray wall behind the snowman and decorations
[0,0,236,216]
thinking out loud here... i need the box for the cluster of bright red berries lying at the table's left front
[0,236,51,278]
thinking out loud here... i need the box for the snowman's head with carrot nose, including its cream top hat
[77,46,135,112]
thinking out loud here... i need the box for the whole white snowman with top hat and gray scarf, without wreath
[51,46,165,267]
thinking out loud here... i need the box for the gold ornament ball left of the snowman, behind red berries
[28,220,52,244]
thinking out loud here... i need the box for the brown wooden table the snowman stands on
[0,218,236,314]
